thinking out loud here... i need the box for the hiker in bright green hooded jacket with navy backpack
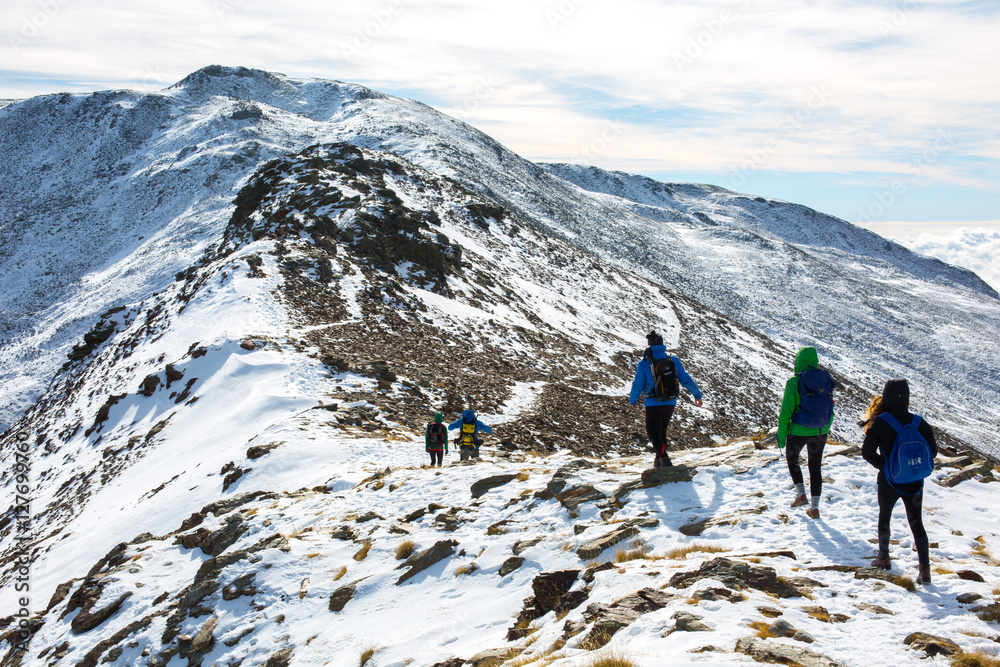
[778,347,837,519]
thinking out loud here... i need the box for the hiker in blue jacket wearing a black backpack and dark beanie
[628,331,701,468]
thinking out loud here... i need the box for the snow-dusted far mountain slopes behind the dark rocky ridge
[0,67,1000,451]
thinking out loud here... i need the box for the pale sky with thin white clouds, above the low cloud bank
[0,0,1000,222]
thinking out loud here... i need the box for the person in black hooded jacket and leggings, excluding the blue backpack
[861,380,937,584]
